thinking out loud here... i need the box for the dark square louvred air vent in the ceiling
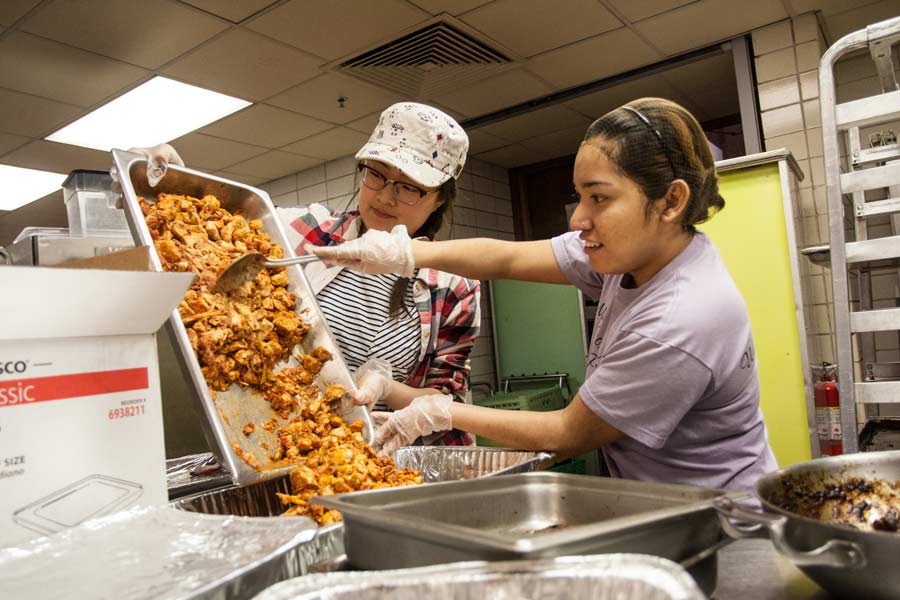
[338,21,512,100]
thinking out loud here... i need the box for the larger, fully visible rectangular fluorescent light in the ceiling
[47,77,251,152]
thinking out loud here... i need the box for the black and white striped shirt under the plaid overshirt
[316,269,422,398]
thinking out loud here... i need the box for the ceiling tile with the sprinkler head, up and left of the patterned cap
[266,73,404,125]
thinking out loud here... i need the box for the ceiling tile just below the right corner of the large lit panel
[200,104,331,148]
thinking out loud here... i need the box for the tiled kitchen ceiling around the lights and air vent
[0,0,900,184]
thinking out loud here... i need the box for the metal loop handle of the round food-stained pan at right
[713,496,866,569]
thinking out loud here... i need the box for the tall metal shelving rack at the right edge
[819,17,900,452]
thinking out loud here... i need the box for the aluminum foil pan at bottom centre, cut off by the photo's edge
[254,554,706,600]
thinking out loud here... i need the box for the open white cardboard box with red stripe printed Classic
[0,255,194,547]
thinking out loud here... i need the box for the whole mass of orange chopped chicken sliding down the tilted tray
[141,194,422,524]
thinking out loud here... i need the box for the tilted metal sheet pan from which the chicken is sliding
[112,150,373,484]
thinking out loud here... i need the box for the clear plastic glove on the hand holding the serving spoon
[306,225,416,277]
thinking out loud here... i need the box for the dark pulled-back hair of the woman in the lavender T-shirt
[584,98,725,232]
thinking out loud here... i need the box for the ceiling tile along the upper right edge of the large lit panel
[163,29,319,101]
